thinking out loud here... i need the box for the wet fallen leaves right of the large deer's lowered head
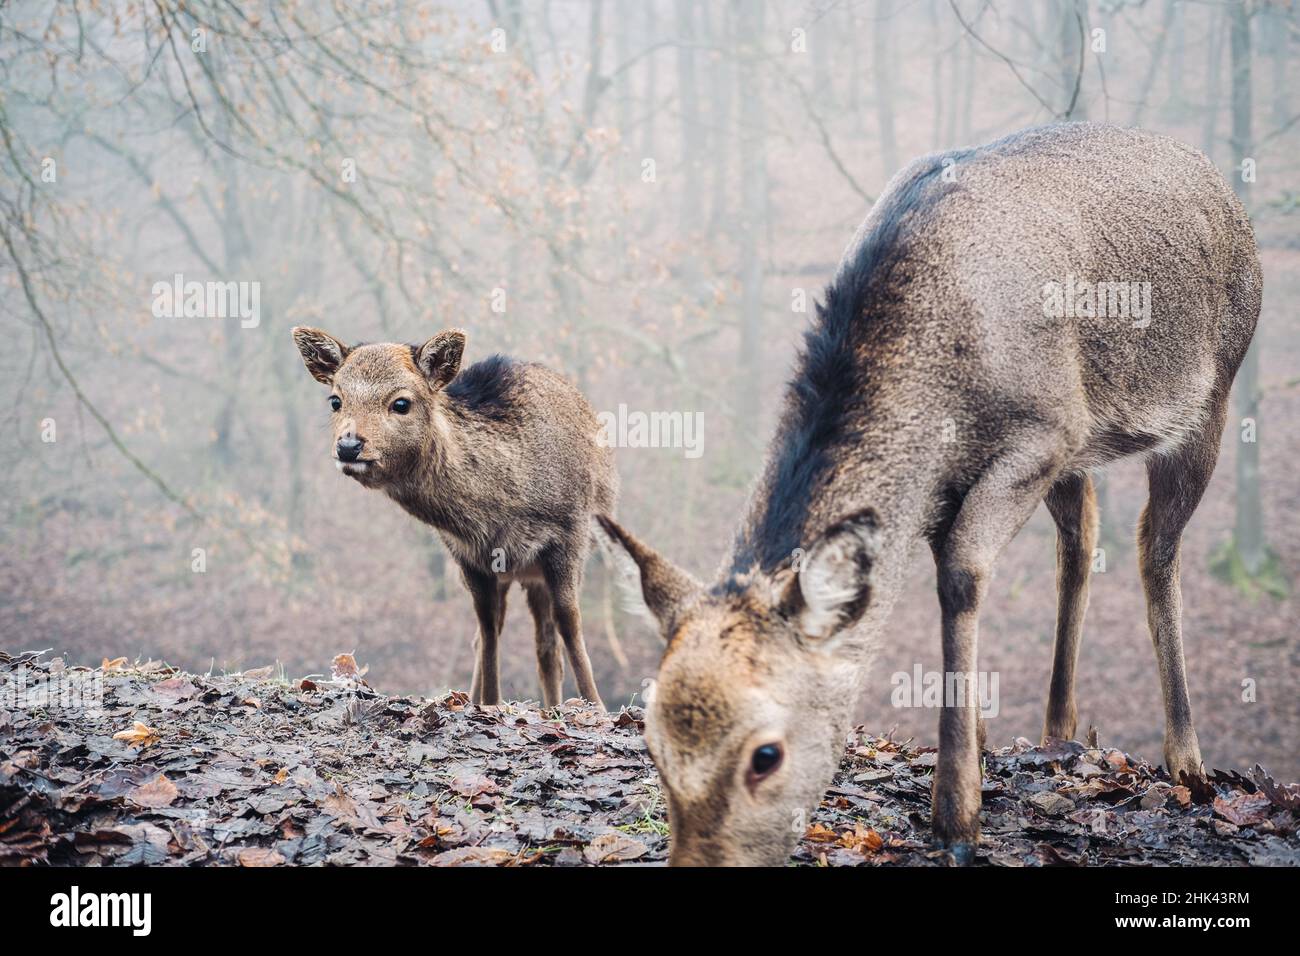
[794,730,1300,866]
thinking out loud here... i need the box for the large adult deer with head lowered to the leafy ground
[599,124,1261,864]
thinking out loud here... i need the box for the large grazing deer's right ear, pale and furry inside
[779,511,879,646]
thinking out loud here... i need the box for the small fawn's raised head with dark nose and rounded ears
[294,326,465,488]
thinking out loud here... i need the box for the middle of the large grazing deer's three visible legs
[1043,475,1097,740]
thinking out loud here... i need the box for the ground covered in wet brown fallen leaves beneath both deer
[0,653,1300,866]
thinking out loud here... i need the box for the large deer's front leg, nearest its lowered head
[933,453,1054,864]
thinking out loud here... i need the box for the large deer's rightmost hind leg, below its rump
[1138,390,1227,784]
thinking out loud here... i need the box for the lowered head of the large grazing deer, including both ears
[599,514,875,866]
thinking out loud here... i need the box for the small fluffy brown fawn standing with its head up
[294,328,618,708]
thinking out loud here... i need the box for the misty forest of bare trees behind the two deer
[0,0,1300,779]
